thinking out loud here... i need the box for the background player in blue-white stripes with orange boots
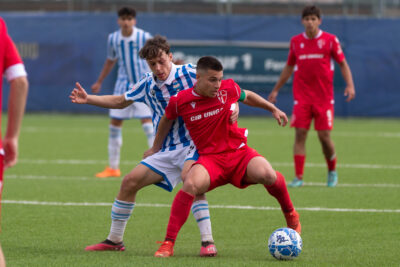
[92,7,154,178]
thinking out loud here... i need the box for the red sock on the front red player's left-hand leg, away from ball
[165,189,194,242]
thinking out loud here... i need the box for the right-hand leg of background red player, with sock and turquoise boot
[318,130,338,187]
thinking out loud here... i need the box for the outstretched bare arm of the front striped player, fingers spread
[69,82,133,109]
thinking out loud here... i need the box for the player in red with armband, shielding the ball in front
[144,57,301,257]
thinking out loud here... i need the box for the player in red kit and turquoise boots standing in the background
[268,6,355,187]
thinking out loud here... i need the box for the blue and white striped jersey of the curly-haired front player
[125,63,196,151]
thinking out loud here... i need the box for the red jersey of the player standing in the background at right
[287,30,344,104]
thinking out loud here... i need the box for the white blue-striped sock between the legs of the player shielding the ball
[192,200,214,242]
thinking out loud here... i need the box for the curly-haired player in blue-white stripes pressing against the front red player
[70,36,238,256]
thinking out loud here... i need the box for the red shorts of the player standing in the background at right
[290,103,334,131]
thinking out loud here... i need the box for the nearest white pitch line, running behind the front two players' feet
[1,200,400,213]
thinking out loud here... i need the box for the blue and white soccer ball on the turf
[268,228,303,260]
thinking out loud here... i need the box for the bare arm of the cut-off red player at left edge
[3,76,28,168]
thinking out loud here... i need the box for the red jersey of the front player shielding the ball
[165,79,247,155]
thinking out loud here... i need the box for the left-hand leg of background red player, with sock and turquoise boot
[288,128,308,187]
